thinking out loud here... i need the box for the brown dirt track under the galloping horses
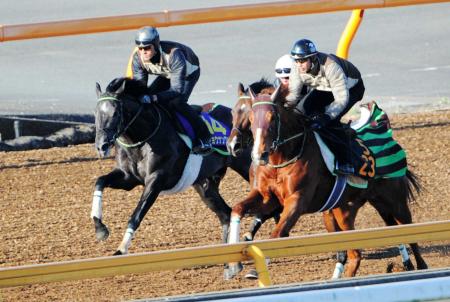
[0,111,450,301]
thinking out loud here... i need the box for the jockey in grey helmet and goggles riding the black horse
[128,26,211,154]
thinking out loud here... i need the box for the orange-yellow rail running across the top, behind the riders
[0,0,450,42]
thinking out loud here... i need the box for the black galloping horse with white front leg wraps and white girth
[91,78,255,254]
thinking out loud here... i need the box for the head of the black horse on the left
[94,78,143,157]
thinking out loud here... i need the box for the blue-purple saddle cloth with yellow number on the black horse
[175,112,230,155]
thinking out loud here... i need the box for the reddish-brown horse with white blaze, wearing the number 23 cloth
[227,85,427,277]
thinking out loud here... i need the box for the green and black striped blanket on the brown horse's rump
[356,102,407,178]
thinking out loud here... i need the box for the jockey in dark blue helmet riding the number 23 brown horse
[286,39,365,174]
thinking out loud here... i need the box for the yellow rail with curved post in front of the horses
[0,220,450,288]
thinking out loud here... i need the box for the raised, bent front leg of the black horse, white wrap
[91,169,138,241]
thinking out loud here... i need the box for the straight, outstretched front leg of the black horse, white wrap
[114,173,164,255]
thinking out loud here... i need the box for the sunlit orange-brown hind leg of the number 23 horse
[332,203,361,277]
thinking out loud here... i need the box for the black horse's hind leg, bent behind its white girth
[193,177,231,243]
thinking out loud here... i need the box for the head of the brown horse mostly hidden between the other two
[227,78,275,156]
